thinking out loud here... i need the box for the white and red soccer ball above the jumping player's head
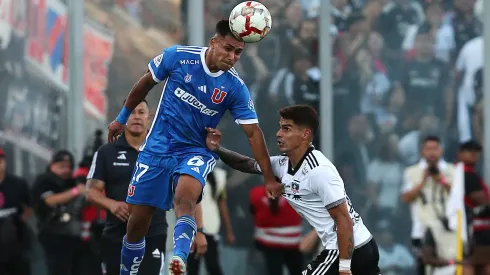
[229,1,272,43]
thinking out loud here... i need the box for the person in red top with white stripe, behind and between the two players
[249,185,303,275]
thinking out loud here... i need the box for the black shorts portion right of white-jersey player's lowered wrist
[351,239,380,275]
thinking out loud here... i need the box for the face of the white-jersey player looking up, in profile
[276,118,311,153]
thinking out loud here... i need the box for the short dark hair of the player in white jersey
[279,105,320,136]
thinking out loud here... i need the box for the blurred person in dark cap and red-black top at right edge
[459,141,490,275]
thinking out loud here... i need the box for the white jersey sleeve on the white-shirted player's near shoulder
[309,166,346,209]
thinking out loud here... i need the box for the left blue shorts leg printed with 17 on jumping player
[126,152,178,210]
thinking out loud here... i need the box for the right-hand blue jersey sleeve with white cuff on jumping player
[229,84,259,124]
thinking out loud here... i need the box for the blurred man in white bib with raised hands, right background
[402,136,454,274]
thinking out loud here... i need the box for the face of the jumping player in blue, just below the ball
[211,35,245,71]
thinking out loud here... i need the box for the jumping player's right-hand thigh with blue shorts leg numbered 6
[173,154,216,202]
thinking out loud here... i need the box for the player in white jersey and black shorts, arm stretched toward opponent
[207,105,380,275]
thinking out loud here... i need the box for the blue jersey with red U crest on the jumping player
[140,45,258,155]
